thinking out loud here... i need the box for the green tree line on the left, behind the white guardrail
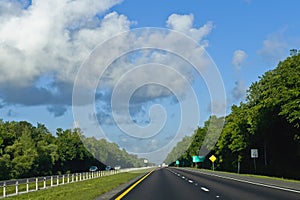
[0,120,143,180]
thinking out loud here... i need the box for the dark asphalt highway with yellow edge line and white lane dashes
[113,168,300,200]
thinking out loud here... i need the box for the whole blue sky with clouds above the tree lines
[0,0,300,163]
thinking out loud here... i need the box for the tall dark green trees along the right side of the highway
[169,54,300,179]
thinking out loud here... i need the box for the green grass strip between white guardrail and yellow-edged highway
[5,172,144,200]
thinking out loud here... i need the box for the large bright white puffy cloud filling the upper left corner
[0,0,125,86]
